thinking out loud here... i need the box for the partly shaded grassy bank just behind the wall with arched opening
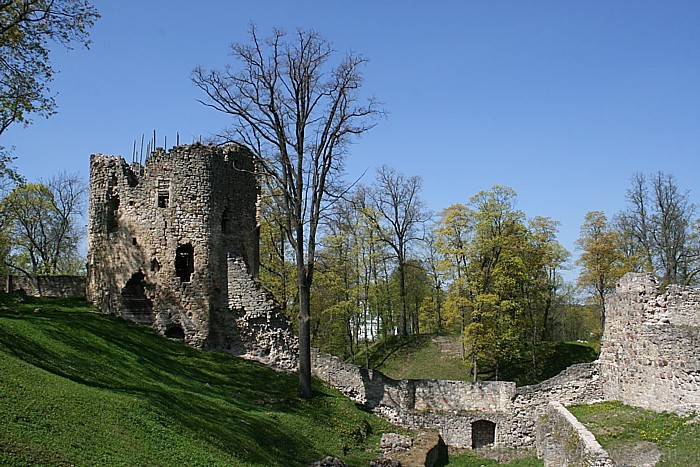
[355,335,598,386]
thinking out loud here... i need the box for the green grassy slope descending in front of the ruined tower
[0,296,397,466]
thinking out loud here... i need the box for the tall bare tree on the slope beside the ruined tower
[192,27,381,398]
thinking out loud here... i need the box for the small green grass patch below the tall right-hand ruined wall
[569,402,700,467]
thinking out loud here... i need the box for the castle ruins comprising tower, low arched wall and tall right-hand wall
[88,144,700,458]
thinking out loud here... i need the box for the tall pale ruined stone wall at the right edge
[599,274,700,414]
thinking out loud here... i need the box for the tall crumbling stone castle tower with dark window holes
[87,144,296,367]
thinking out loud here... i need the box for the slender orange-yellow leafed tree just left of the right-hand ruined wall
[576,211,625,327]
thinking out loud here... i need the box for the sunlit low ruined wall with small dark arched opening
[312,352,602,448]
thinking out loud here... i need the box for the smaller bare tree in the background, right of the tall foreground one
[367,165,430,336]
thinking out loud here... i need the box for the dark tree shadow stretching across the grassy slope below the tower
[0,310,360,465]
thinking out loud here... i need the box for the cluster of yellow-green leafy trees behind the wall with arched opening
[436,186,568,379]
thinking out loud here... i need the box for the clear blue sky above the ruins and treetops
[0,0,700,276]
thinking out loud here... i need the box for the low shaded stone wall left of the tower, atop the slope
[2,275,86,298]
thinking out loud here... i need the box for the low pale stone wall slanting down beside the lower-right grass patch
[537,402,615,467]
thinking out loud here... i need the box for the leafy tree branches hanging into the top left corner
[0,0,99,135]
